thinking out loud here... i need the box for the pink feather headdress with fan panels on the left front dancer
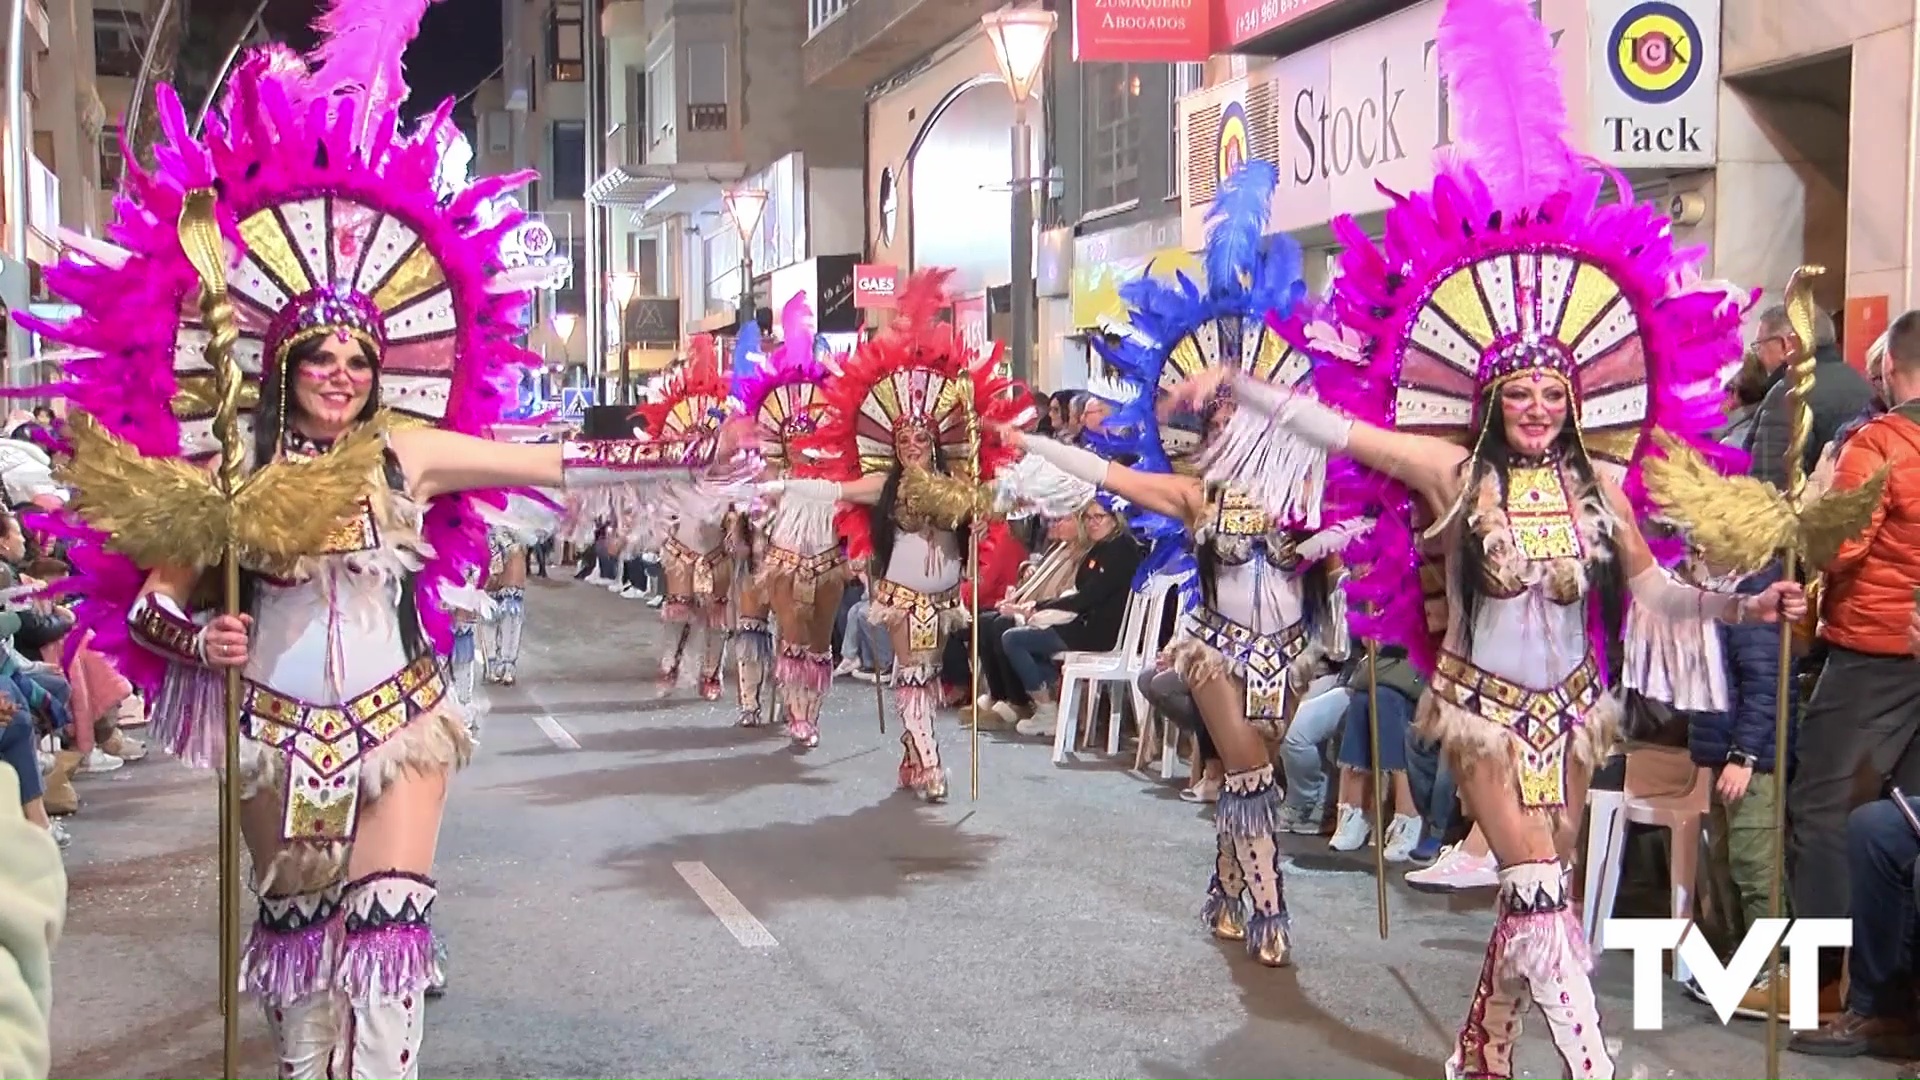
[17,0,540,692]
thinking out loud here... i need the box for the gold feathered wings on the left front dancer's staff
[60,413,386,575]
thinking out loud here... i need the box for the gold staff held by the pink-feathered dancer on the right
[1766,265,1826,1080]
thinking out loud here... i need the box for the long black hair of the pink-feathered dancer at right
[1453,384,1634,651]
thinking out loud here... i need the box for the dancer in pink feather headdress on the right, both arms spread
[1175,0,1805,1080]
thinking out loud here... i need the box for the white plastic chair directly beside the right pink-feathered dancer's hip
[1580,748,1713,982]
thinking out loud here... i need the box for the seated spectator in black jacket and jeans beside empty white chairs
[1000,494,1140,736]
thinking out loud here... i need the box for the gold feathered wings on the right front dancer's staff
[1642,432,1887,573]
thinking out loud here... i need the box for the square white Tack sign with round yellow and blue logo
[1588,0,1720,169]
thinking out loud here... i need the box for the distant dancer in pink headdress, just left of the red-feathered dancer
[733,296,847,748]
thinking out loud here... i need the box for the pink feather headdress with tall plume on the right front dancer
[1315,0,1740,667]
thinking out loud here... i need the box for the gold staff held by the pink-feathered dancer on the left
[179,188,246,1080]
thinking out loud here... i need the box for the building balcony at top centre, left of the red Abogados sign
[801,0,1006,88]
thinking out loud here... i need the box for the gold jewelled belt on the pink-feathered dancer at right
[1428,651,1603,809]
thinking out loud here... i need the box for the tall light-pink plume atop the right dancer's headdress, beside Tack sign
[1434,0,1580,209]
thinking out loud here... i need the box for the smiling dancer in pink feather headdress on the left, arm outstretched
[25,14,748,1080]
